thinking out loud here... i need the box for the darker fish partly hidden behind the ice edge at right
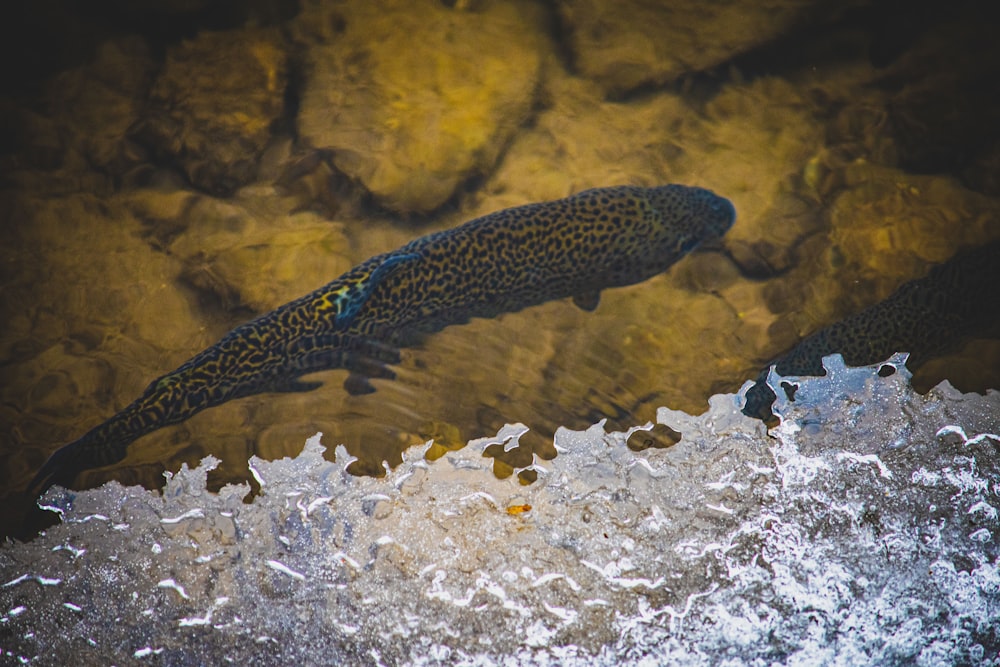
[743,242,1000,423]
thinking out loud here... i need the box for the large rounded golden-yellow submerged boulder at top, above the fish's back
[296,0,543,213]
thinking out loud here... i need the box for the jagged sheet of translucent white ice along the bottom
[0,357,1000,665]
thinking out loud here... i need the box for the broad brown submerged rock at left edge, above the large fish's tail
[0,194,203,498]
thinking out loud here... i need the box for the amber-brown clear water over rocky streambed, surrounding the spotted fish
[0,0,1000,548]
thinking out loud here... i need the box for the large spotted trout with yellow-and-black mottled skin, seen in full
[29,185,735,494]
